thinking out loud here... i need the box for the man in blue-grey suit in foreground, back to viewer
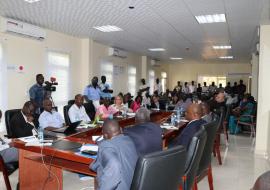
[90,120,138,190]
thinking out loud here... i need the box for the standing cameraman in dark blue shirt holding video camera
[29,74,45,114]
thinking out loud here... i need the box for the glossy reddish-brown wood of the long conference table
[13,112,185,190]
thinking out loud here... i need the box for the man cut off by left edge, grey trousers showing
[0,110,19,163]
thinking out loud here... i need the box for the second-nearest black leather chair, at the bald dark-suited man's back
[183,127,207,190]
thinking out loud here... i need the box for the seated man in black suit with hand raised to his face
[10,101,37,138]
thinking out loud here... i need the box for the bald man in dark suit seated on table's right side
[174,104,206,150]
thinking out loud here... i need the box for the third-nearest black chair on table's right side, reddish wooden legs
[195,118,218,190]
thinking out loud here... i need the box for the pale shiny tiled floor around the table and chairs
[0,136,270,190]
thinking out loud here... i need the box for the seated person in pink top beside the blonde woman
[96,98,118,119]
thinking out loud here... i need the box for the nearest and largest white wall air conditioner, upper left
[0,18,46,40]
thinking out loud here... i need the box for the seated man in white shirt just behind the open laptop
[68,94,91,123]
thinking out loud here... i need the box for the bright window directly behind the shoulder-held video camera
[46,52,71,107]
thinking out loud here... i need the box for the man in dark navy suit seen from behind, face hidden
[124,107,162,155]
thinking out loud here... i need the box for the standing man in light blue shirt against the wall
[83,76,101,109]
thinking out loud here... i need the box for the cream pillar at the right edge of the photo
[255,25,270,160]
